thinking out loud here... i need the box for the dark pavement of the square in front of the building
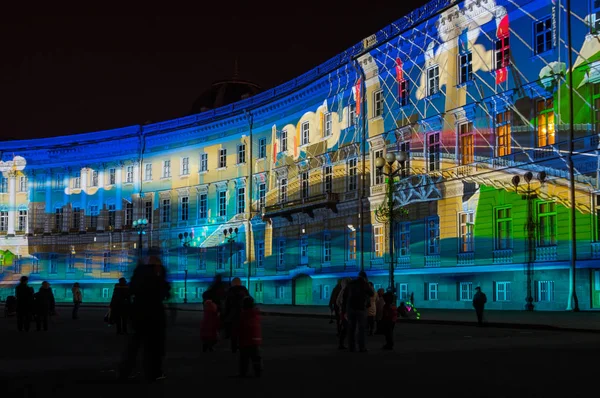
[0,308,600,398]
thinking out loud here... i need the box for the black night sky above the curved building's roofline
[0,0,427,141]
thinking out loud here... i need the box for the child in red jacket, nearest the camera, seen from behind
[239,296,262,377]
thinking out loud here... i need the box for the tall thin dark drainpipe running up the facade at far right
[566,0,579,312]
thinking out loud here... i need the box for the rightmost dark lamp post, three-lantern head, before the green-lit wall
[512,171,546,311]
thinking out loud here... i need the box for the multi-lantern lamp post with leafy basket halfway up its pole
[375,151,408,293]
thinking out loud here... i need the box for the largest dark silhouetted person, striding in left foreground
[117,253,171,382]
